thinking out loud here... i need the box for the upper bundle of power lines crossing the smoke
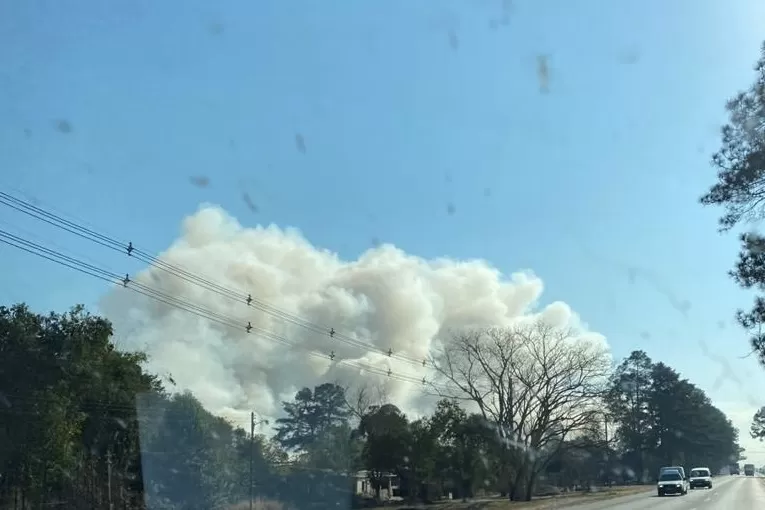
[0,191,432,368]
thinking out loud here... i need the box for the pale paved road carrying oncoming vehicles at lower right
[557,475,765,510]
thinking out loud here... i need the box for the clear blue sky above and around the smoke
[0,0,765,464]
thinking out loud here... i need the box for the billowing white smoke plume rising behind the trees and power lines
[101,205,605,424]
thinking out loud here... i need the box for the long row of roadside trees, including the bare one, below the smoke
[0,305,740,510]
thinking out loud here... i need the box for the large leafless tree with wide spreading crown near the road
[433,320,610,500]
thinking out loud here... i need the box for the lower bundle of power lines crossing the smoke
[0,230,442,390]
